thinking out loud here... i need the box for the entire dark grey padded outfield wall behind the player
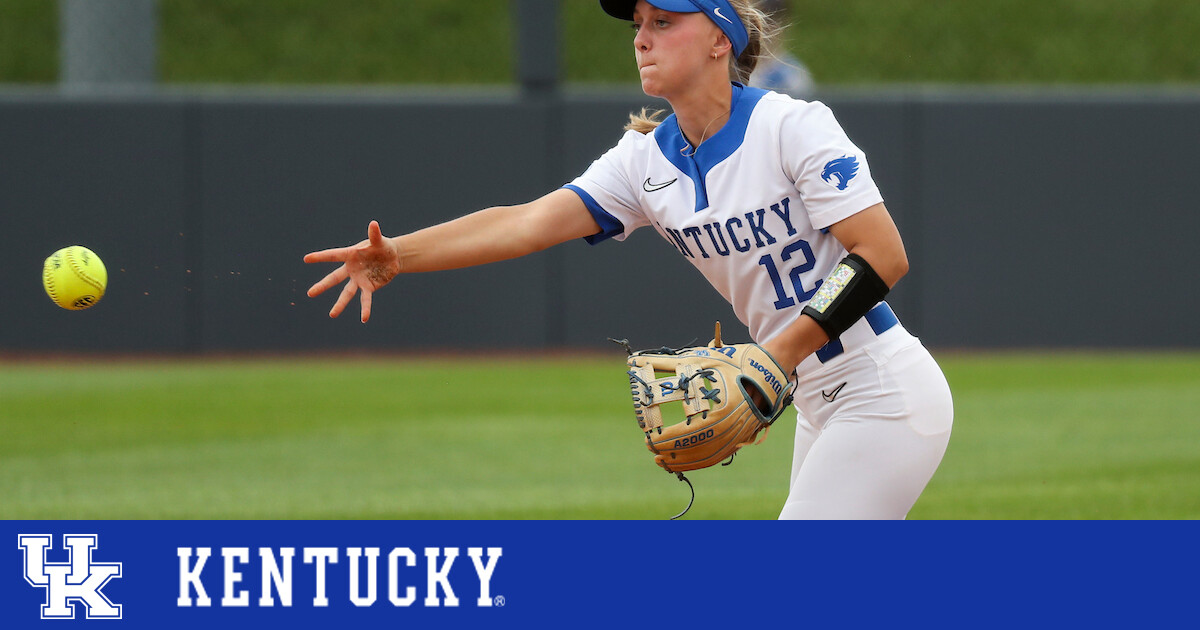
[0,88,1200,353]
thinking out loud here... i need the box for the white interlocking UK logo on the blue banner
[17,534,121,619]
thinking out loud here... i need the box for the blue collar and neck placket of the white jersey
[654,83,767,212]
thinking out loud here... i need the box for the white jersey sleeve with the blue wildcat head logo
[780,102,883,229]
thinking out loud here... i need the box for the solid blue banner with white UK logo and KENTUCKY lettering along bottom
[0,521,1200,630]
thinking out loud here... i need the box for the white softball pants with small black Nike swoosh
[779,324,954,520]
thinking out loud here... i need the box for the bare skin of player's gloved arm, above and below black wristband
[762,203,908,373]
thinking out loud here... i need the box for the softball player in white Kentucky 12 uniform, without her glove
[305,0,953,518]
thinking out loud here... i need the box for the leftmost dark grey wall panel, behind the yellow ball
[0,98,194,352]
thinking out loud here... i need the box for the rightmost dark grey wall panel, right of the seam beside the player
[918,98,1200,347]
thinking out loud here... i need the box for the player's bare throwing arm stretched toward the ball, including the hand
[304,188,600,323]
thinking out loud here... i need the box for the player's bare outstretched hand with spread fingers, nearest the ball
[304,221,400,324]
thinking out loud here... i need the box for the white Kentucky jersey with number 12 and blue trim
[566,83,883,343]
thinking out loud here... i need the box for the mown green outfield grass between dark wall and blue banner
[0,353,1200,520]
